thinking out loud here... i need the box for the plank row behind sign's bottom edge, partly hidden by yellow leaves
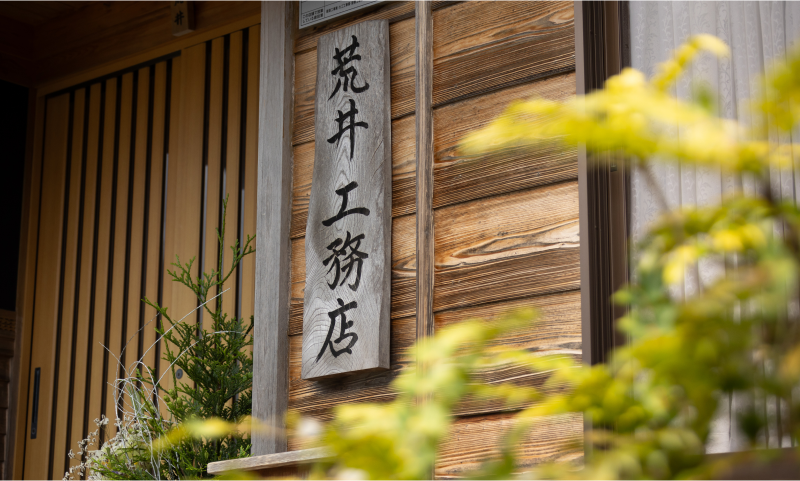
[289,291,581,424]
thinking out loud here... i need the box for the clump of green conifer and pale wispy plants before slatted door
[64,198,254,481]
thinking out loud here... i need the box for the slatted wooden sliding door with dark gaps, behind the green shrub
[15,25,259,481]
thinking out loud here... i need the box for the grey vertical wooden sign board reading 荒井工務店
[302,20,392,379]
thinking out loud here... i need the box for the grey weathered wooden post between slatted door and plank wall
[252,0,294,456]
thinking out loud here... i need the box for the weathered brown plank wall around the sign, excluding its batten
[289,0,583,470]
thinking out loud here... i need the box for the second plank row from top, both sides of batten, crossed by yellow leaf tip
[291,74,578,238]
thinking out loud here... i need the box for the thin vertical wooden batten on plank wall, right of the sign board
[416,0,434,340]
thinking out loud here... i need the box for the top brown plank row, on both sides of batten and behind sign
[293,0,575,145]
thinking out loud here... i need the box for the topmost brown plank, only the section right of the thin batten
[433,0,575,106]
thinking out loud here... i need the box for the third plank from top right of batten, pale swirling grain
[433,182,580,311]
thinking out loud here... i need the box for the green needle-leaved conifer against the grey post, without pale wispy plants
[144,197,255,474]
